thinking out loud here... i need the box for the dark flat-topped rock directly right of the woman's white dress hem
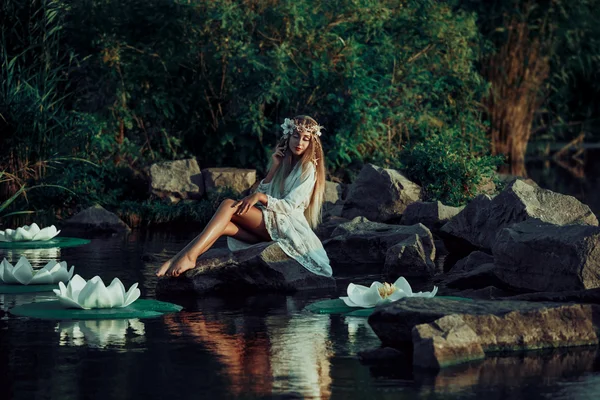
[323,217,435,272]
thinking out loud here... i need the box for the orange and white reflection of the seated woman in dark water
[165,296,333,399]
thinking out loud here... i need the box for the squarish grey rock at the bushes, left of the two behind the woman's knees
[150,159,204,202]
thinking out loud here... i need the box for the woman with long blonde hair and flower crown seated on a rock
[157,115,331,276]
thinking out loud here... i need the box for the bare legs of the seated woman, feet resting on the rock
[157,199,271,276]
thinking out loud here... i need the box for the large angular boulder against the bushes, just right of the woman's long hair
[342,164,421,222]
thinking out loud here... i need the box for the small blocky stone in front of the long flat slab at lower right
[412,315,485,369]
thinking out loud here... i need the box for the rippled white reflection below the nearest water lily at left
[54,318,145,351]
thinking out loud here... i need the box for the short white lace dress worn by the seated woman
[227,163,332,276]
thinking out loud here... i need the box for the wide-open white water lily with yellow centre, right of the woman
[340,277,438,308]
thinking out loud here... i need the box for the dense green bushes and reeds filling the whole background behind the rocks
[0,0,600,226]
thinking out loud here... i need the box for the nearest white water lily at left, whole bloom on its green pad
[54,275,140,310]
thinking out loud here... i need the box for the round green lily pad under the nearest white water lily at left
[8,299,183,320]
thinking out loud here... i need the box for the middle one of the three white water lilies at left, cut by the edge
[0,257,75,285]
